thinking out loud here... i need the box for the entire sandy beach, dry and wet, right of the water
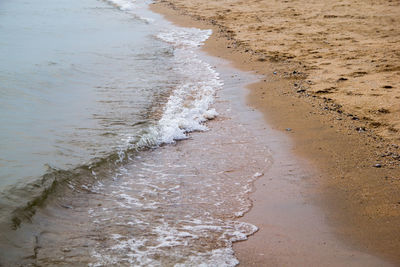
[152,0,400,266]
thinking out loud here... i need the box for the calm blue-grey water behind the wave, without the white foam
[0,0,167,189]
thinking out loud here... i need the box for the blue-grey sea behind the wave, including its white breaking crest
[0,0,220,224]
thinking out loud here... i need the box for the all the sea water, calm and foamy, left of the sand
[0,0,268,266]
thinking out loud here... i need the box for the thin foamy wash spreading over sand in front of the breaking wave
[0,50,271,266]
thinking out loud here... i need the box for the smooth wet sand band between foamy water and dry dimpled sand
[153,2,400,266]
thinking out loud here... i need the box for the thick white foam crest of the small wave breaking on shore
[140,28,223,148]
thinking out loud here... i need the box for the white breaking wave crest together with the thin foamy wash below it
[0,3,269,266]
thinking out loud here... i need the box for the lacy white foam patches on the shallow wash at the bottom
[88,148,257,267]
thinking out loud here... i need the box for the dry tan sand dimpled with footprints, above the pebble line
[158,0,400,143]
